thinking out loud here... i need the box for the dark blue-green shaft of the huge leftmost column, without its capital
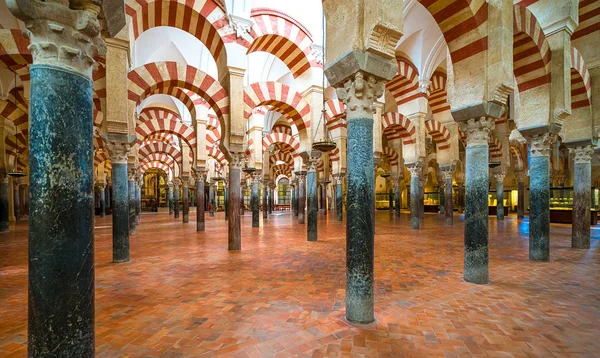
[27,64,95,357]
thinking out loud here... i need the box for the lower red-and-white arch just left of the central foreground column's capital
[244,82,310,132]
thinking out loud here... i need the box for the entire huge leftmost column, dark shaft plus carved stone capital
[10,1,105,357]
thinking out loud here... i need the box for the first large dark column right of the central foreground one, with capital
[459,117,494,284]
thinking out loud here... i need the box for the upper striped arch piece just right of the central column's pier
[386,57,426,105]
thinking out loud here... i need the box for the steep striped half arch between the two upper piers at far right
[513,5,552,92]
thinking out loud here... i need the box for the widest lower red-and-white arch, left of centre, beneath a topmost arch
[127,62,229,126]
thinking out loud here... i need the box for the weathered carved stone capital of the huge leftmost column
[6,0,106,77]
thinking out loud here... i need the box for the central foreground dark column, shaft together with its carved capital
[331,71,385,324]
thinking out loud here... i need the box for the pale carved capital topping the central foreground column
[337,72,385,119]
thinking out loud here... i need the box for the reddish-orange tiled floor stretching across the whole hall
[0,211,600,357]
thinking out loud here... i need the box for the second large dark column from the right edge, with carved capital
[524,126,556,261]
